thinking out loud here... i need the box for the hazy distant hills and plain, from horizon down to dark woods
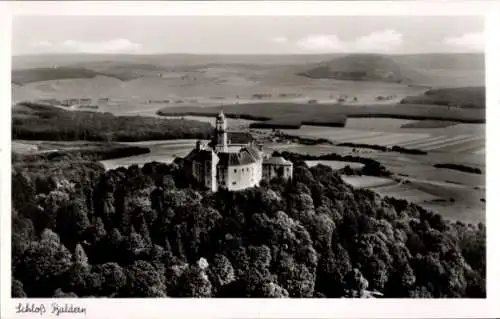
[8,54,485,107]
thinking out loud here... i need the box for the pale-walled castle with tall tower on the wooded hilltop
[184,111,293,192]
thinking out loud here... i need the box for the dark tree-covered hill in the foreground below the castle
[12,161,486,297]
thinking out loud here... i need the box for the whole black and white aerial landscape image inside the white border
[2,0,494,315]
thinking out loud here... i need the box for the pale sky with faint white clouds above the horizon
[12,16,485,55]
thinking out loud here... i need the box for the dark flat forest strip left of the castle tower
[12,102,213,142]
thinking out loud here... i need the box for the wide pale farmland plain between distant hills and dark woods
[12,66,424,111]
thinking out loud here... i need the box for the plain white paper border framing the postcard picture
[0,1,500,319]
